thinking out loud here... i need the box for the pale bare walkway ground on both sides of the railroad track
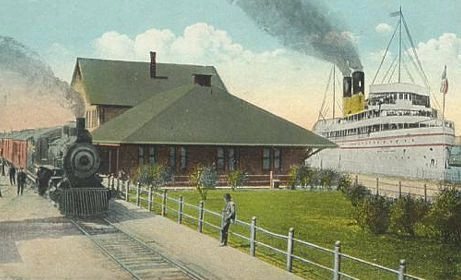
[0,176,301,280]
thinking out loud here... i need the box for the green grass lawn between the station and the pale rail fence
[138,190,461,279]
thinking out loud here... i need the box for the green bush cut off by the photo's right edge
[429,187,461,244]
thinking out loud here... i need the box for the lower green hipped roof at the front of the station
[93,84,336,148]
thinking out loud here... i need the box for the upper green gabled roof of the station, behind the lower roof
[72,58,225,107]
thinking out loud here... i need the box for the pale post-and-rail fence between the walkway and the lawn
[104,178,422,280]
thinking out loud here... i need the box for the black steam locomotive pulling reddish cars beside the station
[0,118,112,216]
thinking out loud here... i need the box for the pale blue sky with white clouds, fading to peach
[0,0,461,131]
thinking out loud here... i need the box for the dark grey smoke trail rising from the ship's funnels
[229,0,362,76]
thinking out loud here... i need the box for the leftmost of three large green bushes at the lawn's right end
[355,195,391,234]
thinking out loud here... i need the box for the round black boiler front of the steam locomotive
[64,143,101,178]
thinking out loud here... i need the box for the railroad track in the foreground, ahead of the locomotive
[71,218,204,280]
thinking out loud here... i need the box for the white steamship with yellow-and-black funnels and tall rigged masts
[307,11,459,180]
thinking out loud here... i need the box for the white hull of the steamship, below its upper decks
[307,126,455,180]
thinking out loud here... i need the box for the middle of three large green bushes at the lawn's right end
[390,195,430,236]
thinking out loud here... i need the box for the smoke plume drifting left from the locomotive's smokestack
[0,36,84,131]
